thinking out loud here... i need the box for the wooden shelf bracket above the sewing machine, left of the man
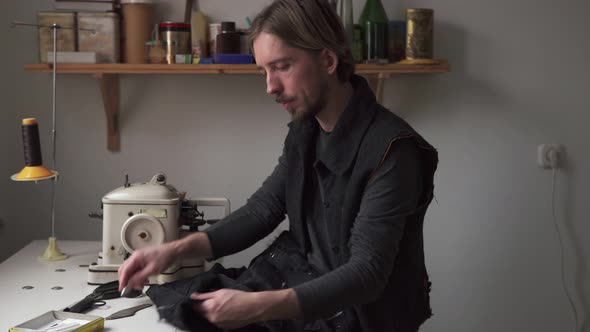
[94,73,121,152]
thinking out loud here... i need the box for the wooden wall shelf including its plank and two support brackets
[25,60,450,151]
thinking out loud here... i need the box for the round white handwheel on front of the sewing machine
[121,213,166,253]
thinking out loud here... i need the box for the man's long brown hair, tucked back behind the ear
[248,0,354,82]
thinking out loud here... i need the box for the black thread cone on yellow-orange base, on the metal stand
[11,118,57,181]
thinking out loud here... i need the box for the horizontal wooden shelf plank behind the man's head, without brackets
[25,61,450,75]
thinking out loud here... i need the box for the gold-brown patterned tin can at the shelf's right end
[406,8,434,60]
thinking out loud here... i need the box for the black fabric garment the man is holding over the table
[146,231,358,332]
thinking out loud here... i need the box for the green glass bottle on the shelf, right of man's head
[359,0,389,62]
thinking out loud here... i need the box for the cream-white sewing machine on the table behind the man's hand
[87,173,230,285]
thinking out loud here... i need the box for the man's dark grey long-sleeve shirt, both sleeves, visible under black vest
[206,136,422,318]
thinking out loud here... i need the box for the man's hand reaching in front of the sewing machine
[119,243,175,290]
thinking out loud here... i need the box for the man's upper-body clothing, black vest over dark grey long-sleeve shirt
[206,75,438,324]
